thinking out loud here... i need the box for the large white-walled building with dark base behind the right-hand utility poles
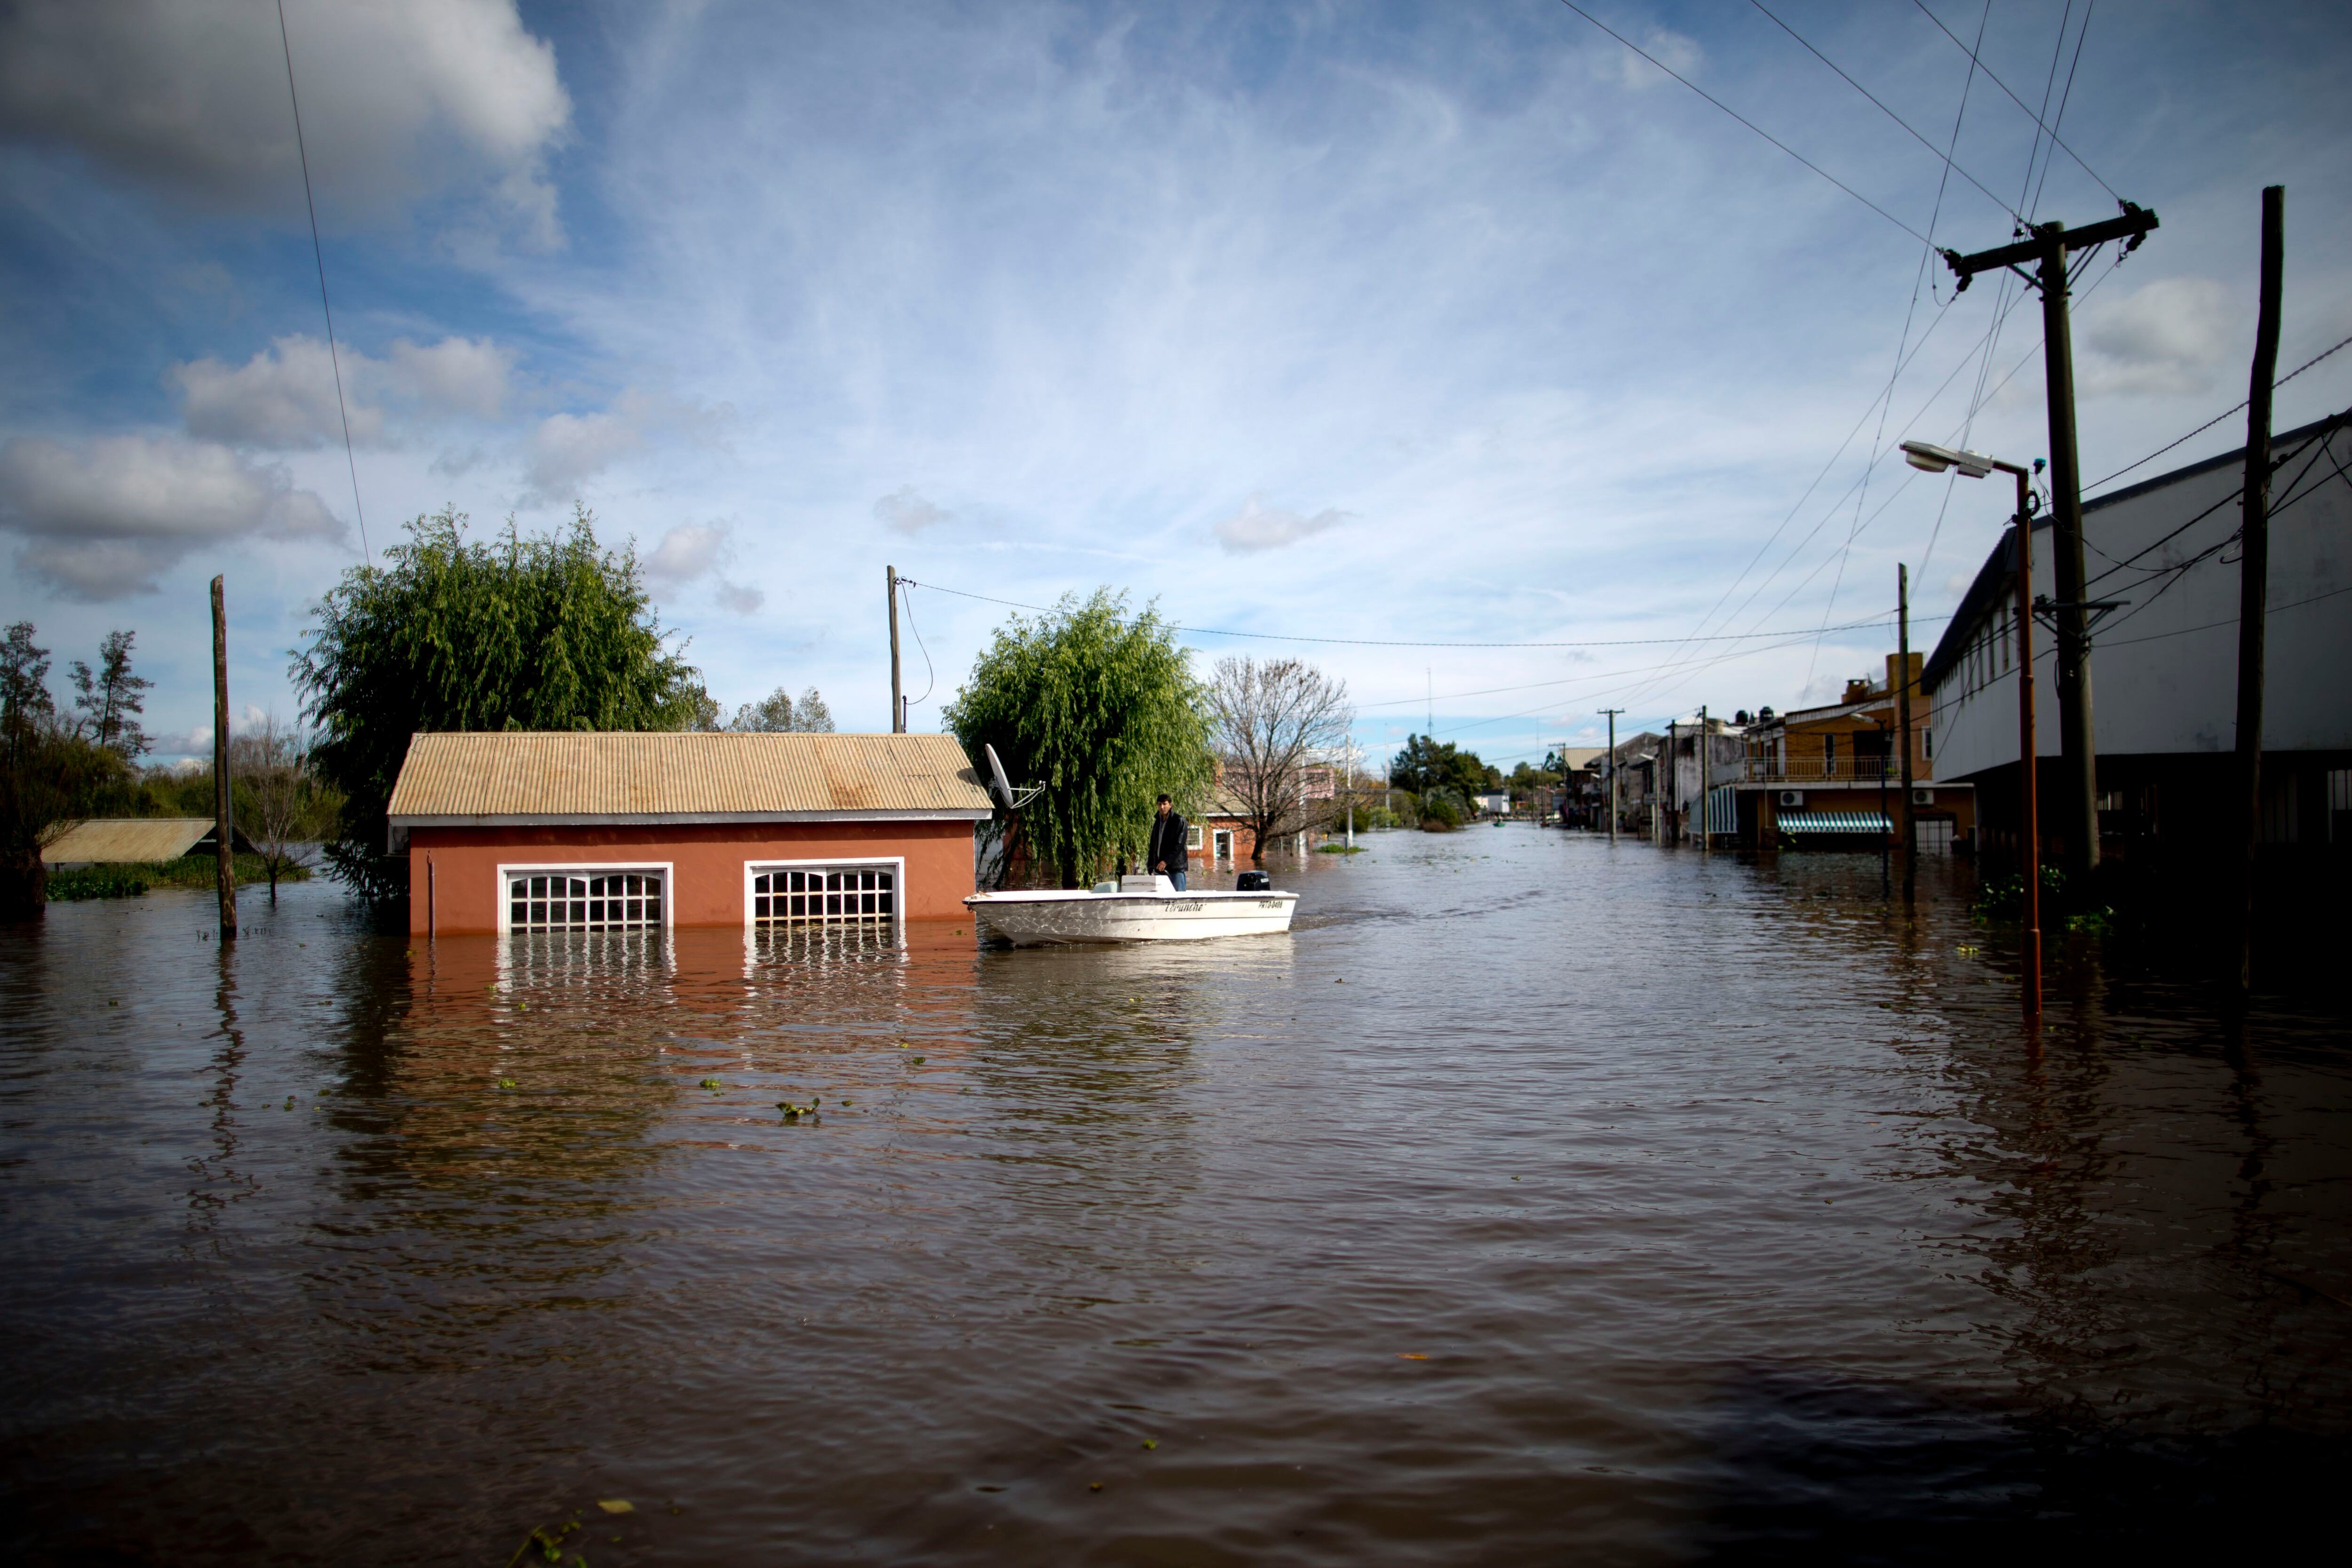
[1924,421,2352,858]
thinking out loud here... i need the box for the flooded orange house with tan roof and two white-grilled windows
[388,731,990,936]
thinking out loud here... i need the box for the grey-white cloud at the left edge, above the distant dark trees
[0,435,346,599]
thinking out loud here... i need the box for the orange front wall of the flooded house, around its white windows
[409,820,974,936]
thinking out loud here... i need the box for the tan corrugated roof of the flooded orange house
[390,731,990,825]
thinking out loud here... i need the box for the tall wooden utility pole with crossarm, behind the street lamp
[1943,202,2157,875]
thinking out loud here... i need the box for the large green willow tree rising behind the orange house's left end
[292,508,701,900]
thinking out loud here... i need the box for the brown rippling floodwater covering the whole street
[0,828,2352,1568]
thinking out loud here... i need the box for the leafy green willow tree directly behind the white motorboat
[943,588,1214,886]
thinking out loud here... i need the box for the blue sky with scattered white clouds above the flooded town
[0,0,2352,766]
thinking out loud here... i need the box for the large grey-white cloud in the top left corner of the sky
[0,0,572,242]
